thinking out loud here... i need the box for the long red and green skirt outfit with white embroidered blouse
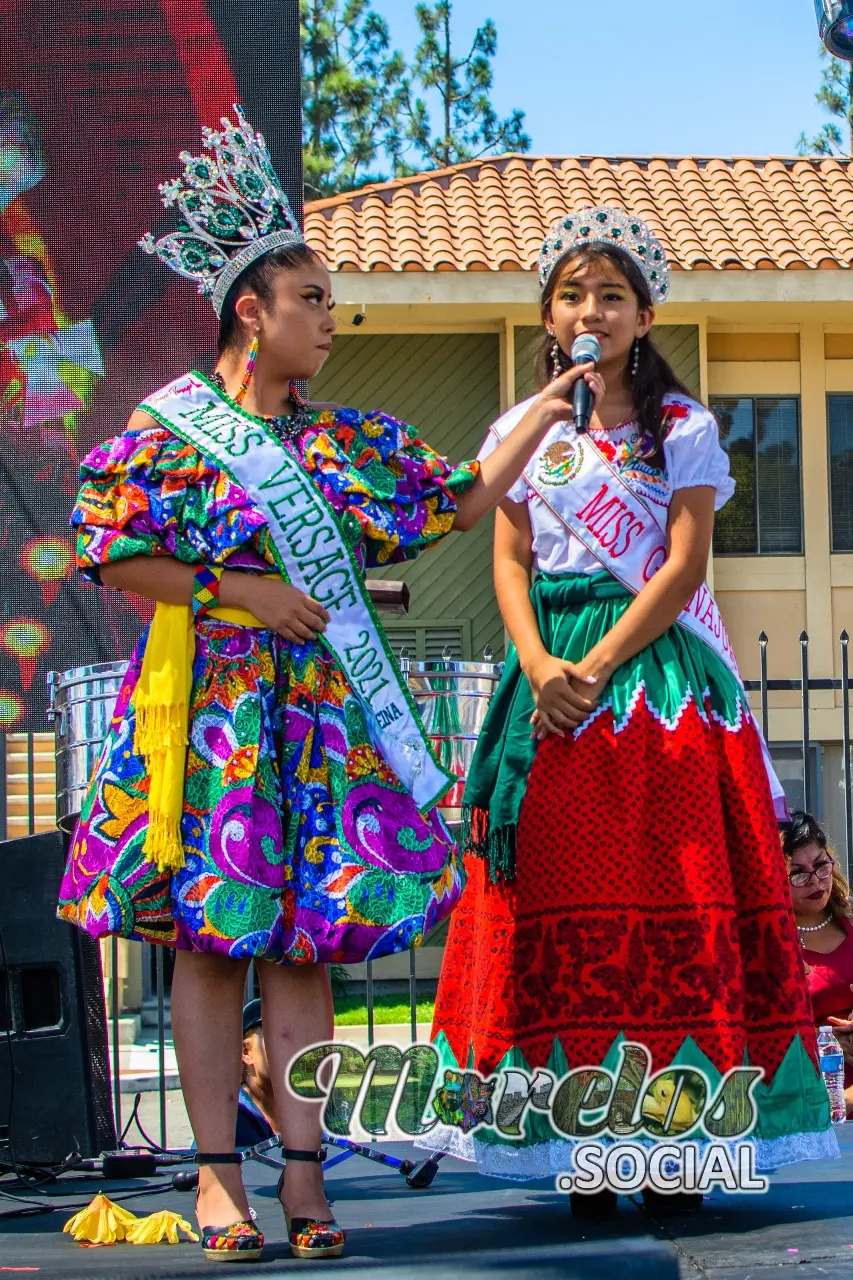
[421,398,836,1178]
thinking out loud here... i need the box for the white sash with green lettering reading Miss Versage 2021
[140,372,456,813]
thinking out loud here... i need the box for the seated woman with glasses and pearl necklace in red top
[783,810,853,1115]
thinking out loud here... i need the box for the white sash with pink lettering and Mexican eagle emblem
[489,401,788,820]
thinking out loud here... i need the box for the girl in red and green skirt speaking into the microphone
[421,207,836,1203]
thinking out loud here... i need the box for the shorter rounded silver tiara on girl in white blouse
[539,205,670,303]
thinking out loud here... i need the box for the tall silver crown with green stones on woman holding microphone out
[140,105,305,315]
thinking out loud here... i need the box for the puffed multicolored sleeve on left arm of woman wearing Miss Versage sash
[70,426,264,582]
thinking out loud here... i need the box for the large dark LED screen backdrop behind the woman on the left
[0,0,301,731]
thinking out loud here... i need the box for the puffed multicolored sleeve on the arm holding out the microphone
[316,410,479,568]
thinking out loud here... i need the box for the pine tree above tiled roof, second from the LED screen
[387,0,530,174]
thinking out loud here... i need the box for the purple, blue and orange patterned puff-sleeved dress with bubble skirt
[59,384,478,964]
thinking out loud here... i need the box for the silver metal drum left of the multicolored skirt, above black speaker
[47,662,127,832]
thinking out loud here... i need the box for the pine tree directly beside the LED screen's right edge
[301,0,406,200]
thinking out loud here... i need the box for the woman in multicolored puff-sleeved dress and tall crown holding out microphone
[59,111,601,1260]
